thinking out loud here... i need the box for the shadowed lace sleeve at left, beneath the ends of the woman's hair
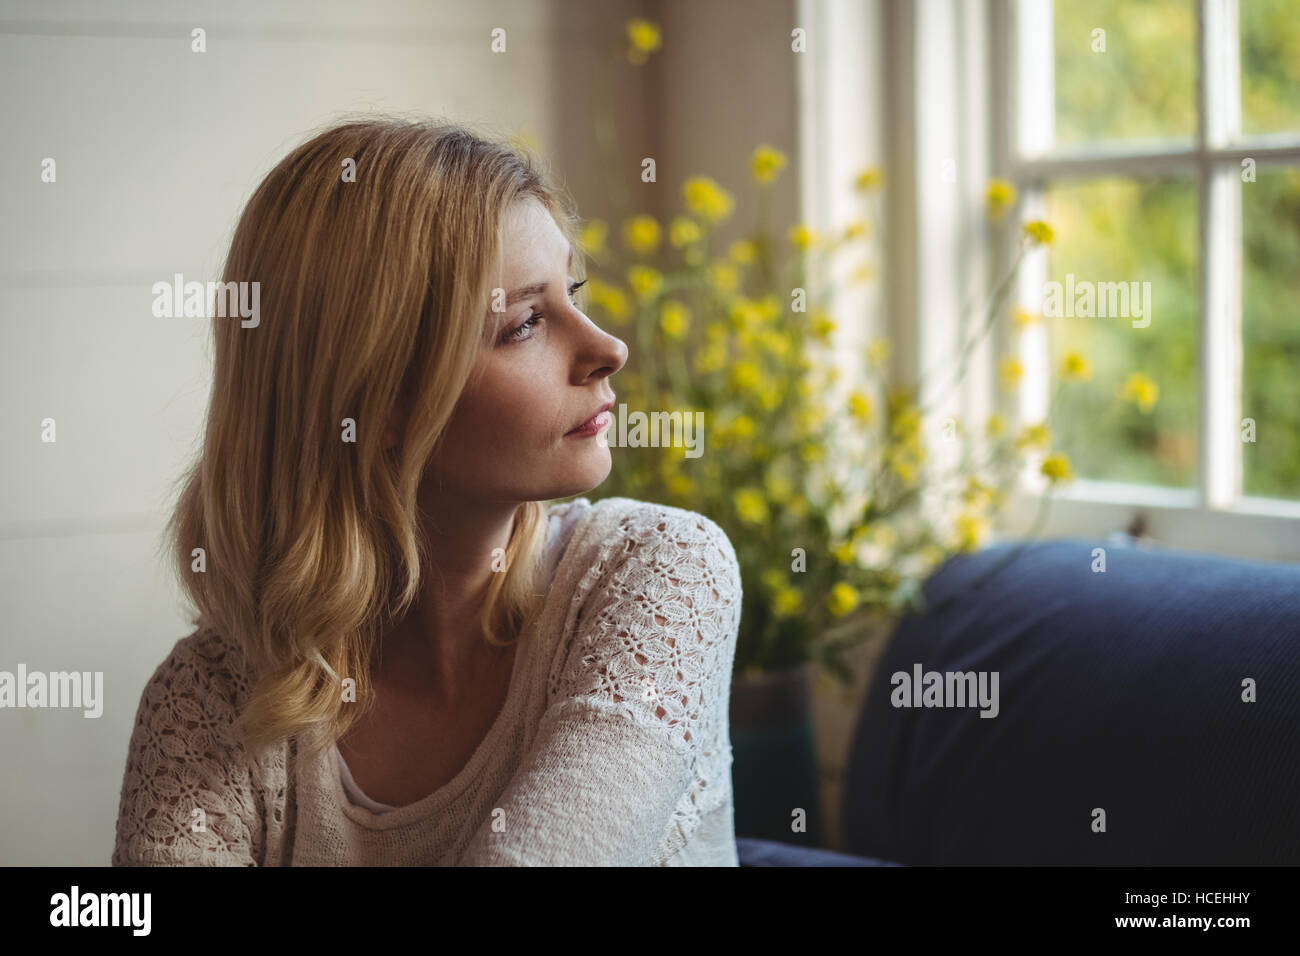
[112,641,261,866]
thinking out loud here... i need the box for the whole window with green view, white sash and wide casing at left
[797,0,1300,561]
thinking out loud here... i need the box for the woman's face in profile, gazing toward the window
[423,199,628,502]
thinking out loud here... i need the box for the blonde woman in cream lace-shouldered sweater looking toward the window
[113,118,741,866]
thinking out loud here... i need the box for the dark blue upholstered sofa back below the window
[844,540,1300,866]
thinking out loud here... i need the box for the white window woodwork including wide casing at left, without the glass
[794,0,1300,562]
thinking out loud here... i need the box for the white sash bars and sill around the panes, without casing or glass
[988,0,1300,561]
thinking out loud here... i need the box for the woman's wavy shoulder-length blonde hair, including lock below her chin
[166,117,582,764]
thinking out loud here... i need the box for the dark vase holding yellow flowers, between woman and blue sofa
[731,663,822,847]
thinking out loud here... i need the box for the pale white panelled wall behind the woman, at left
[0,0,639,865]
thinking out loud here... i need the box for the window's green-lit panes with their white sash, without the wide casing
[992,0,1300,559]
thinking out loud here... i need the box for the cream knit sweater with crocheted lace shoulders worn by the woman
[112,498,741,866]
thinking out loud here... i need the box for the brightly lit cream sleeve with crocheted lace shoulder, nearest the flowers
[462,505,741,865]
